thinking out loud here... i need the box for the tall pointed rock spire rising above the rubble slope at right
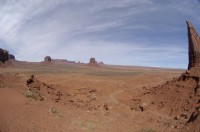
[187,21,200,69]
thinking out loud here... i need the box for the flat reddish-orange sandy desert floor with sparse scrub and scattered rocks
[0,64,183,132]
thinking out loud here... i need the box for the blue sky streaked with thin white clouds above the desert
[0,0,200,68]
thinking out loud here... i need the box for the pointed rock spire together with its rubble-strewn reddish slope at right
[131,22,200,132]
